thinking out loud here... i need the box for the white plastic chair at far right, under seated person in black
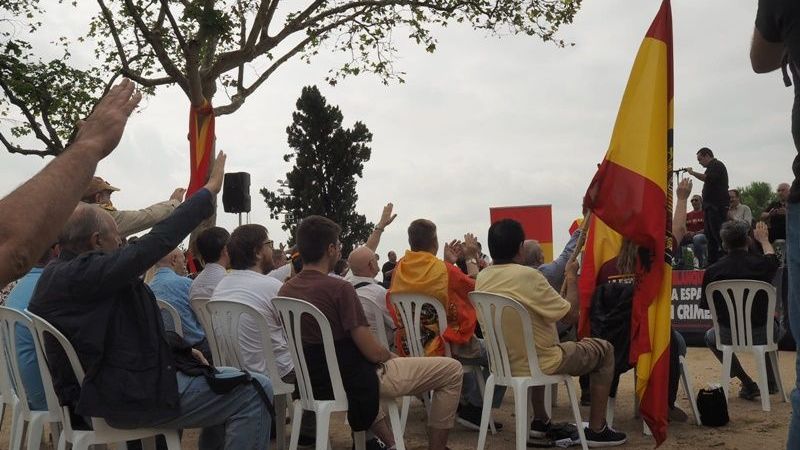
[706,280,789,411]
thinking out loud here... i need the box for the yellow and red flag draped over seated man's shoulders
[386,251,478,356]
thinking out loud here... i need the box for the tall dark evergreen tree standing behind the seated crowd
[261,86,373,256]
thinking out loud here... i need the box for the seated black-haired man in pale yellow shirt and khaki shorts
[475,219,627,447]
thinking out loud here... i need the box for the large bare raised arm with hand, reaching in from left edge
[0,80,141,286]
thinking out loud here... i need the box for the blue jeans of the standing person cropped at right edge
[786,203,800,449]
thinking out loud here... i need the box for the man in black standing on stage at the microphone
[689,147,730,264]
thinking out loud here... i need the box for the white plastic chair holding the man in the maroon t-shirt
[272,297,405,450]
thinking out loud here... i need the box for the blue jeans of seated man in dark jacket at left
[109,368,272,450]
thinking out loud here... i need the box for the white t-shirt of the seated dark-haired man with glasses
[211,270,294,378]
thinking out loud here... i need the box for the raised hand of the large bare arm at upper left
[72,78,142,158]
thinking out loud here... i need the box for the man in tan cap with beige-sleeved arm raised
[82,177,186,239]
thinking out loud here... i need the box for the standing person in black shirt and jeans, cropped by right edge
[750,0,800,448]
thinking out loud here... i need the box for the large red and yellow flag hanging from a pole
[584,0,673,444]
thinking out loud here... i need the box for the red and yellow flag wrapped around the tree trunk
[186,100,215,198]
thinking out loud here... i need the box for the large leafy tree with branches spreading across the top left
[0,0,581,156]
